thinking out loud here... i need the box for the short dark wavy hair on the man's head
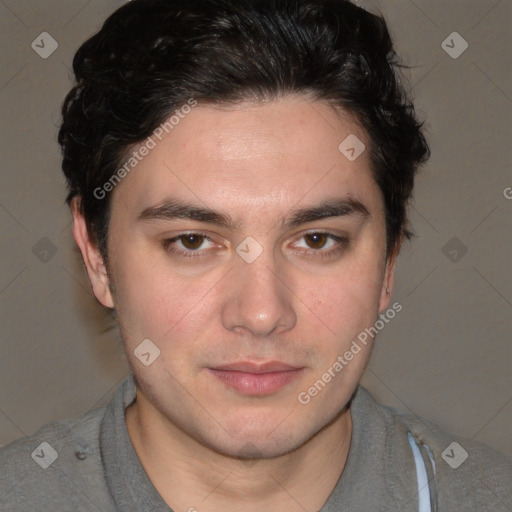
[59,0,430,262]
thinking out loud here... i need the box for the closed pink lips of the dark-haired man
[207,361,304,396]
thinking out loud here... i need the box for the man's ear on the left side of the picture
[70,197,114,308]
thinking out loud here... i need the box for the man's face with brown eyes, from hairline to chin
[75,97,393,457]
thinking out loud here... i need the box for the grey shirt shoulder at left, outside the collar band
[0,408,115,511]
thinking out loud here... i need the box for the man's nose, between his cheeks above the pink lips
[221,247,297,337]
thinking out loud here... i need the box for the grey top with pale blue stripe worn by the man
[0,375,512,512]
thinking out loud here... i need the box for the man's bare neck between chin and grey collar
[126,390,352,512]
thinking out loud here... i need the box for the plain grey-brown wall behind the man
[0,0,512,454]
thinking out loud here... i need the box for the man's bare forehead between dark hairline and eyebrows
[114,97,380,224]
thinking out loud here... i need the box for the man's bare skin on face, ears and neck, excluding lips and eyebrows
[72,96,395,512]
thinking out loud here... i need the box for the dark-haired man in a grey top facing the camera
[0,0,512,512]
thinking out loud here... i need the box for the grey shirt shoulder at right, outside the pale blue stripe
[372,390,512,512]
